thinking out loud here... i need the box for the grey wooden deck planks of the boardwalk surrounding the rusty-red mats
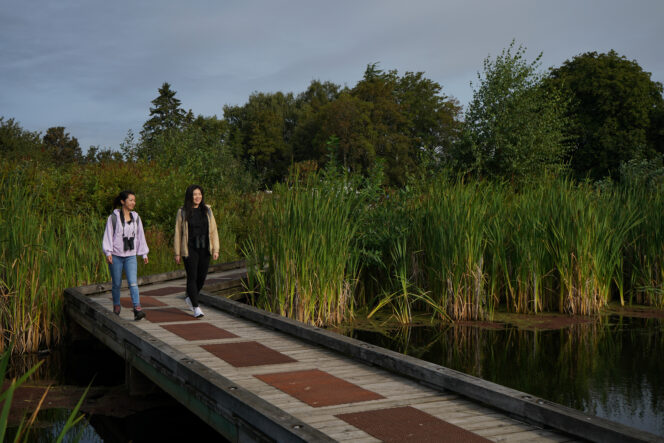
[87,294,546,441]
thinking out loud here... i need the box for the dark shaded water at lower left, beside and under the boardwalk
[6,339,224,443]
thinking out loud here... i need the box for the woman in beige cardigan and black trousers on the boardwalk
[173,185,219,318]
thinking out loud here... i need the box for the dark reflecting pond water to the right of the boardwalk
[347,315,664,436]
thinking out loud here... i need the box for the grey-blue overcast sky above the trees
[0,0,664,152]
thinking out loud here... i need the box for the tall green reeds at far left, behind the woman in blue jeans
[0,171,175,353]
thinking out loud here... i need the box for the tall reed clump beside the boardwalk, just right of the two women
[245,176,363,326]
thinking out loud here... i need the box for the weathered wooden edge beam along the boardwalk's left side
[65,288,335,442]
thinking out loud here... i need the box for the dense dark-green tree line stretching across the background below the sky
[0,42,664,188]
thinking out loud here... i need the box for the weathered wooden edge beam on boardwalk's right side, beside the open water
[199,291,664,442]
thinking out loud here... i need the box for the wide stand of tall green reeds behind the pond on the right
[412,179,652,320]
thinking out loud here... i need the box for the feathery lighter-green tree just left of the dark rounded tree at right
[460,41,567,182]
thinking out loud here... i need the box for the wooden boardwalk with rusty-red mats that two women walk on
[66,269,658,443]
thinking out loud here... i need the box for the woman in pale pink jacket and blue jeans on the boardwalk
[102,191,150,320]
